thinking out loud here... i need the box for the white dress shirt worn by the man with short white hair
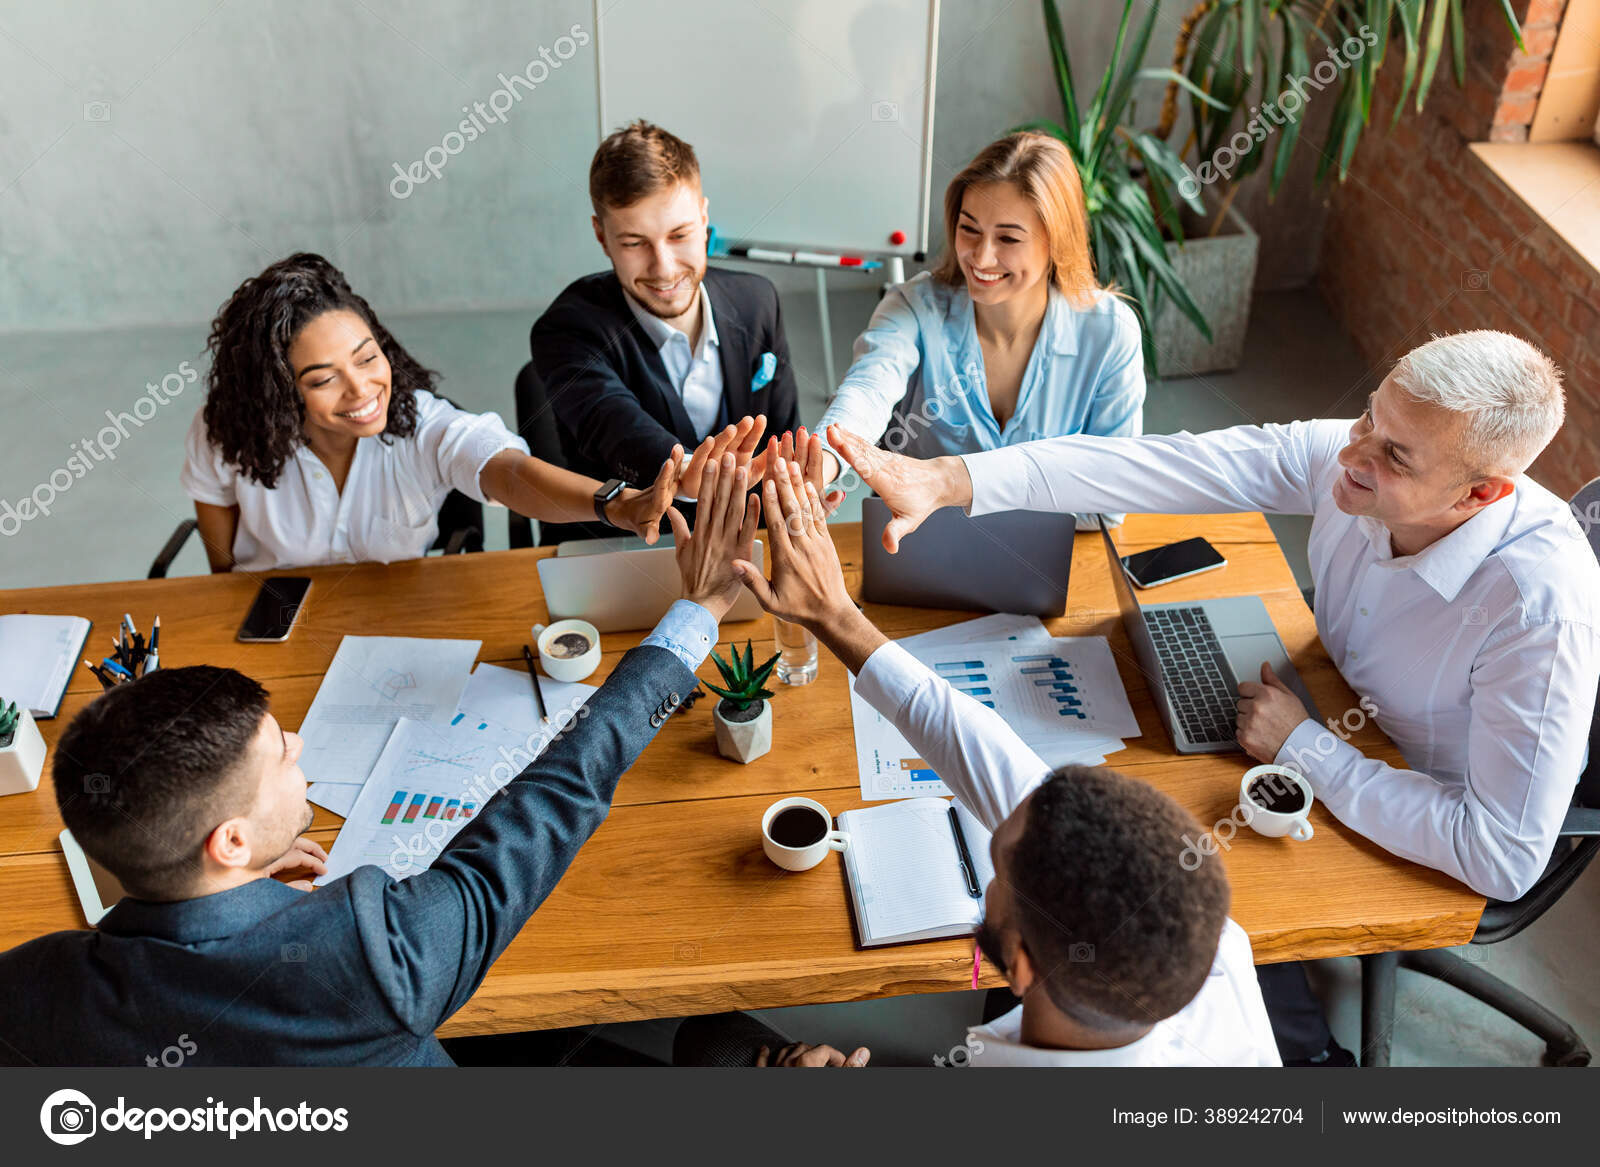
[965,421,1600,900]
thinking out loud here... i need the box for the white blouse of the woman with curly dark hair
[179,389,528,571]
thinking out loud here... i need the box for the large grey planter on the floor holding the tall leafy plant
[1154,207,1261,376]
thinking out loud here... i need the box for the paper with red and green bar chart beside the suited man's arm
[317,714,554,884]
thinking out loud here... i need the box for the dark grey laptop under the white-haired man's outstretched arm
[861,496,1077,616]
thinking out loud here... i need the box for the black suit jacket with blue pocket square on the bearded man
[528,267,800,487]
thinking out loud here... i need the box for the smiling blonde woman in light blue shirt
[818,133,1144,499]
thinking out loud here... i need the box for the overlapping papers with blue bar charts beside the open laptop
[850,616,1139,799]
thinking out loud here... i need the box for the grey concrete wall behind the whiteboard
[0,0,1318,331]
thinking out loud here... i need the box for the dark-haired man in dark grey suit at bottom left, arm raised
[0,455,758,1066]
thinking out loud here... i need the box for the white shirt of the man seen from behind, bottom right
[856,642,1282,1066]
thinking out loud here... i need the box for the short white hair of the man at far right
[1390,328,1566,474]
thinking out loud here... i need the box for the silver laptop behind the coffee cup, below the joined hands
[539,539,765,632]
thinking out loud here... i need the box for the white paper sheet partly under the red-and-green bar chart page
[299,636,483,804]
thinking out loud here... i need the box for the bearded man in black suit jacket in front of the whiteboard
[530,122,800,496]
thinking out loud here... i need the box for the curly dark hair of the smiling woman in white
[205,251,438,490]
